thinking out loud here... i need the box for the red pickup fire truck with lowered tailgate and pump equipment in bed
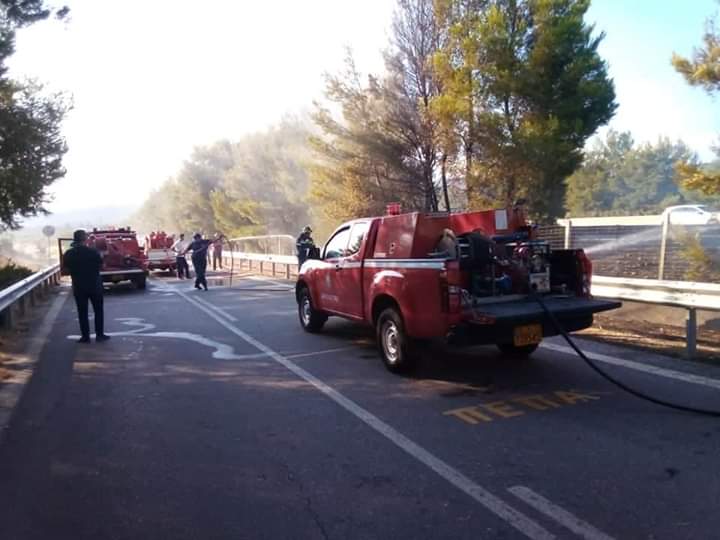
[296,206,620,372]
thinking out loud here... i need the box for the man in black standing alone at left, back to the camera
[63,229,110,343]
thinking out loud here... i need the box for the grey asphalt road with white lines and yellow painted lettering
[0,280,720,540]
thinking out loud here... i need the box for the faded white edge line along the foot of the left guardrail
[0,291,69,443]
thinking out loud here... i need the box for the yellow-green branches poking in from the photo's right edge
[672,2,720,195]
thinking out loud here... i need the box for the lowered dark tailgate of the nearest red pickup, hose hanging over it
[466,295,622,324]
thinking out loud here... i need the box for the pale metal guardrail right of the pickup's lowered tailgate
[592,276,720,358]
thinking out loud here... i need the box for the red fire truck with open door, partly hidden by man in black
[58,227,148,289]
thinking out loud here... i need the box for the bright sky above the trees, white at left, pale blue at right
[5,0,720,212]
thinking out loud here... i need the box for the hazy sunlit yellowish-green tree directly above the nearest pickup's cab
[310,57,432,221]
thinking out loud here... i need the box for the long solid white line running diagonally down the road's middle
[176,291,555,540]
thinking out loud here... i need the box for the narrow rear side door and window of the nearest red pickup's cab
[335,222,370,319]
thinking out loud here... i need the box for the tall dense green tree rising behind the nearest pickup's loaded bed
[433,0,616,219]
